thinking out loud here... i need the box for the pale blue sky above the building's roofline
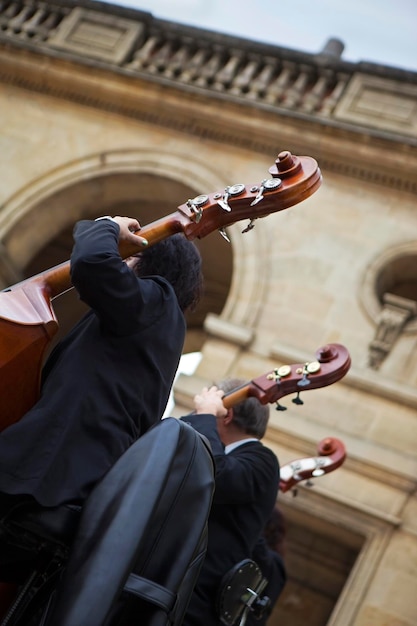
[101,0,417,72]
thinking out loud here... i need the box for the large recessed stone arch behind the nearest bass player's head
[0,149,265,350]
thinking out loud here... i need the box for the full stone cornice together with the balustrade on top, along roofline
[0,0,417,193]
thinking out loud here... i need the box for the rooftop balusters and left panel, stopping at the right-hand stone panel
[0,0,354,116]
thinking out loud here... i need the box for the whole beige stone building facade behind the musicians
[0,0,417,626]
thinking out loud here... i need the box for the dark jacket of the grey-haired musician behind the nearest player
[183,415,279,626]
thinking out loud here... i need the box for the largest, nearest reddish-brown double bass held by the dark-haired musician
[0,151,321,430]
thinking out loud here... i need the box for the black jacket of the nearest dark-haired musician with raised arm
[0,220,185,506]
